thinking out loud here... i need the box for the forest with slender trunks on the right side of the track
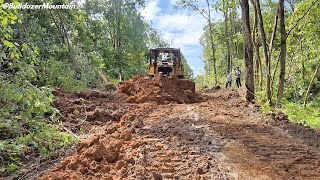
[194,0,320,128]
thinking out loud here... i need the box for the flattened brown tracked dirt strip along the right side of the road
[200,90,320,179]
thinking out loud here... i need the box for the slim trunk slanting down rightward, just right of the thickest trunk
[254,0,272,105]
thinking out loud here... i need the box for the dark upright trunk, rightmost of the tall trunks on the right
[277,0,287,107]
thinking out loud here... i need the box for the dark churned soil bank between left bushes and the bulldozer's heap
[54,90,131,132]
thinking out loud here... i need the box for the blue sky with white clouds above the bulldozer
[141,0,220,76]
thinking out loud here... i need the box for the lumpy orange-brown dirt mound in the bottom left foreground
[40,126,139,180]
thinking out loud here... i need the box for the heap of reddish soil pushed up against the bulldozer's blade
[118,75,199,104]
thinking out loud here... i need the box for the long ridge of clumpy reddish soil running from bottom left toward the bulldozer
[40,106,158,180]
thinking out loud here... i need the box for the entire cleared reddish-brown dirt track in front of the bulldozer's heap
[18,87,320,180]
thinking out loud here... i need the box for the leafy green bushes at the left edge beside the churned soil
[0,3,75,174]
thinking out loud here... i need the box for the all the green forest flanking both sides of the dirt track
[0,0,320,177]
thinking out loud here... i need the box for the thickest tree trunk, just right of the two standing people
[241,0,254,102]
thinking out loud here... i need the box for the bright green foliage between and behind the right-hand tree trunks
[196,0,320,128]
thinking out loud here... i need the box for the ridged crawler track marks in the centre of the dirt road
[136,105,232,179]
